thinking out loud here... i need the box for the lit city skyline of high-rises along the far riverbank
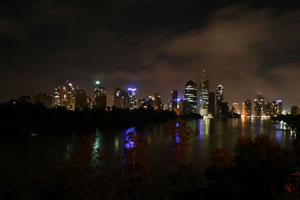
[30,78,288,117]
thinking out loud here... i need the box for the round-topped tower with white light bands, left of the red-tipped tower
[183,80,197,113]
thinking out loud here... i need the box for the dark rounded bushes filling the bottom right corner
[205,135,300,199]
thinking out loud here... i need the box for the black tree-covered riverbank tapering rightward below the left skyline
[0,97,176,135]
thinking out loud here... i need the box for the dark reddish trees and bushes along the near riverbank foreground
[0,119,300,199]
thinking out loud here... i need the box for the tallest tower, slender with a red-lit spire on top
[199,70,209,116]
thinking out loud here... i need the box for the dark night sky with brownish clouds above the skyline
[0,0,300,111]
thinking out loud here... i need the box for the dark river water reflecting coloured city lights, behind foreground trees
[0,119,294,196]
